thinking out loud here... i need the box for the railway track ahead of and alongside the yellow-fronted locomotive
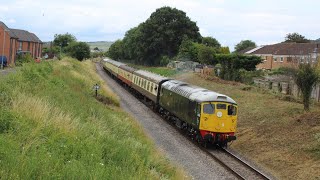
[100,63,271,179]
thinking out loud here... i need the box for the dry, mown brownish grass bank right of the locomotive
[176,73,320,179]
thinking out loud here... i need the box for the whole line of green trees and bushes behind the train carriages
[108,7,260,69]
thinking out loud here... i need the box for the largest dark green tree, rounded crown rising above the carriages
[119,7,201,65]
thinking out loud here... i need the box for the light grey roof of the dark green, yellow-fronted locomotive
[162,80,236,104]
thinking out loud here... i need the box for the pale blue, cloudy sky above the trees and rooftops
[0,0,320,50]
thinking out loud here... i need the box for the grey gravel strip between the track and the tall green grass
[96,63,235,179]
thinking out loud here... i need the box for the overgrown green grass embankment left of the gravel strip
[0,59,183,179]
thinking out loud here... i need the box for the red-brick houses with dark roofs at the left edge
[0,21,43,64]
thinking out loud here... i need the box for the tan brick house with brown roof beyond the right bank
[244,43,320,70]
